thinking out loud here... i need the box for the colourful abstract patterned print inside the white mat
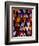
[12,8,32,37]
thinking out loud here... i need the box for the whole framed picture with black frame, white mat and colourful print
[5,1,38,45]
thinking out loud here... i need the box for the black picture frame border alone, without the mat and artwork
[5,1,38,45]
